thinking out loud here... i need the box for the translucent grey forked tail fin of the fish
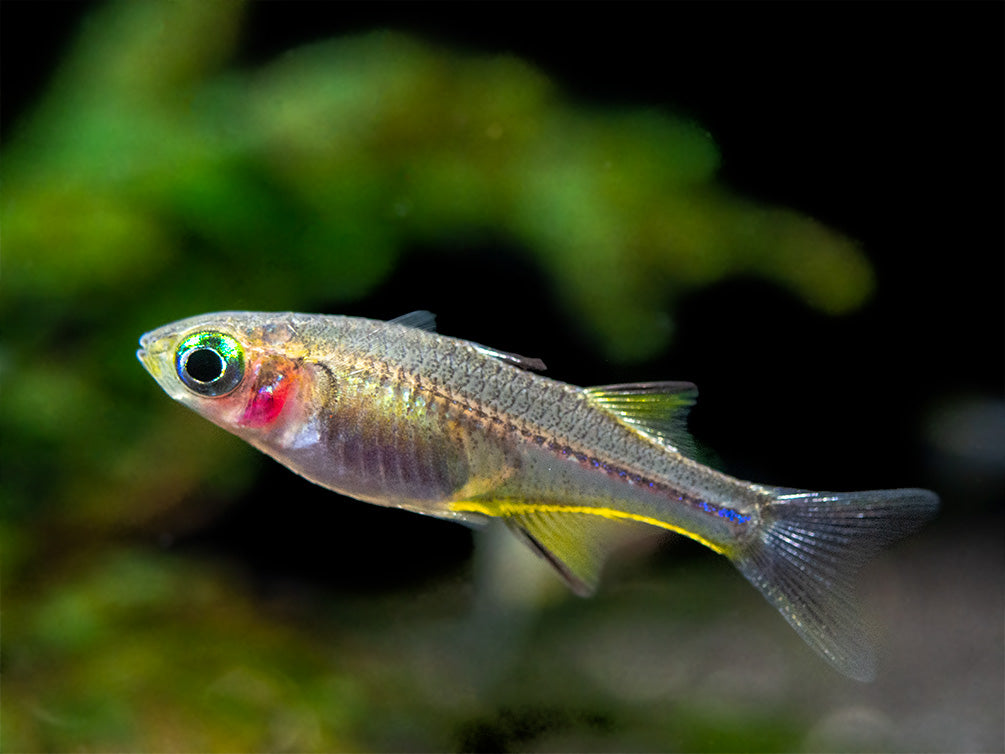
[733,489,939,681]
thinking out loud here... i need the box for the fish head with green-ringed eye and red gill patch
[137,312,315,444]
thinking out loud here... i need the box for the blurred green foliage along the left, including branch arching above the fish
[0,0,872,750]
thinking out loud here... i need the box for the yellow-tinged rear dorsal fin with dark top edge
[585,382,697,457]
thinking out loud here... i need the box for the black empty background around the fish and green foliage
[2,2,1005,589]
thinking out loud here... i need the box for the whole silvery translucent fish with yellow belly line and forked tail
[137,312,939,681]
